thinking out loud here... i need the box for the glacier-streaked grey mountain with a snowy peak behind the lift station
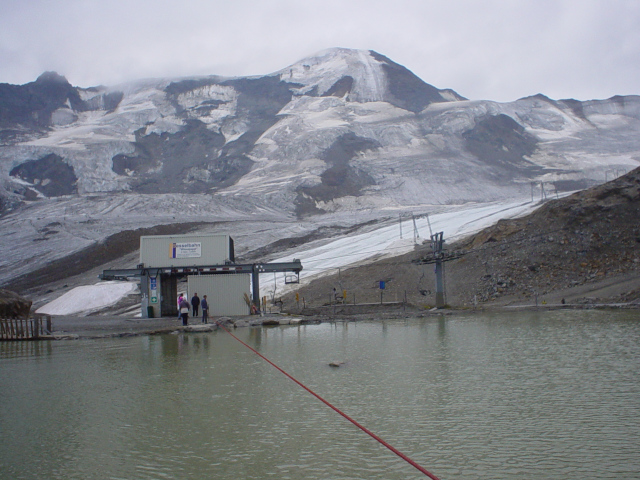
[0,49,640,290]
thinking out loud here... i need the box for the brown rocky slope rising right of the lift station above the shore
[283,168,640,311]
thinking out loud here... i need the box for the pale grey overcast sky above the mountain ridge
[0,0,640,102]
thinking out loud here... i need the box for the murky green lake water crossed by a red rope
[0,311,640,480]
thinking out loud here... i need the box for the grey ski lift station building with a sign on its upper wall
[100,234,302,318]
